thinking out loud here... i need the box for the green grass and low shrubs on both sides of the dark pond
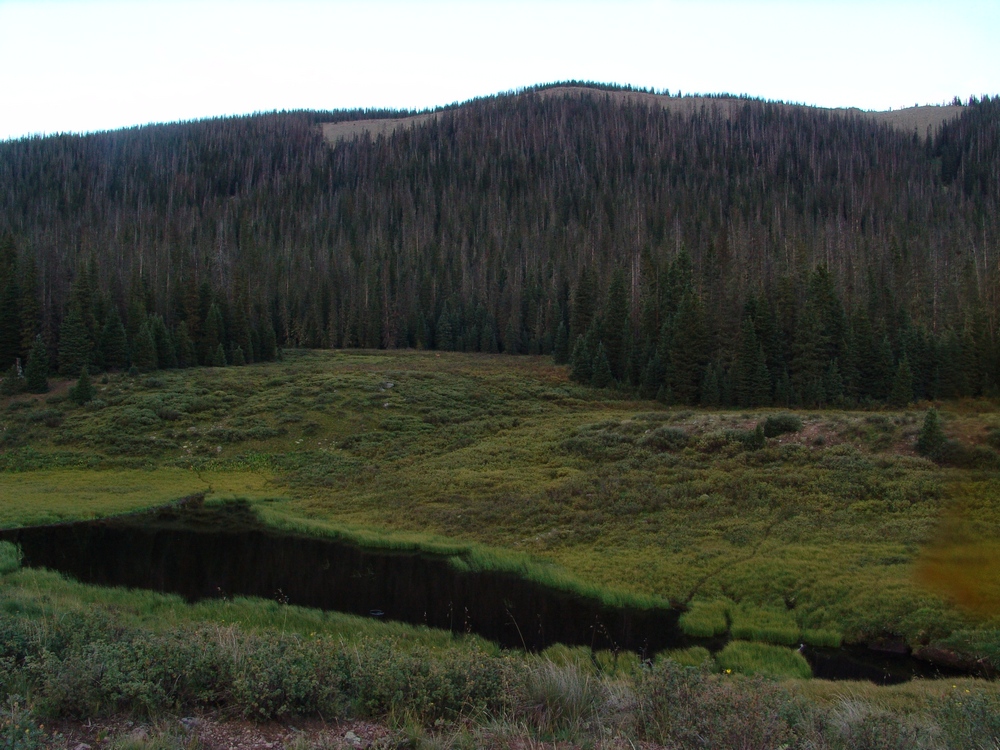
[0,351,1000,747]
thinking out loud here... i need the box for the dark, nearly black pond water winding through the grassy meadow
[0,499,980,683]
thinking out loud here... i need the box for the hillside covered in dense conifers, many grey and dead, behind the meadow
[0,83,1000,406]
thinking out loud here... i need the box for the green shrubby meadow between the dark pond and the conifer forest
[0,351,1000,658]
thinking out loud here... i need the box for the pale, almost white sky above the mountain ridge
[0,0,1000,139]
